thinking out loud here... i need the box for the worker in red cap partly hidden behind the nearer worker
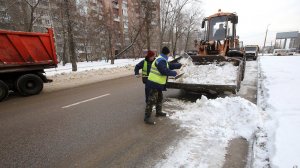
[134,50,155,103]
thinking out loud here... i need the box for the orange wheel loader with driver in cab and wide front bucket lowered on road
[167,10,246,94]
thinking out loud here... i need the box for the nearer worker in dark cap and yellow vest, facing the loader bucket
[144,47,181,124]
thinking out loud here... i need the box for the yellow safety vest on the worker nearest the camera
[148,55,169,85]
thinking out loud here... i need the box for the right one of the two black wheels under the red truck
[17,74,44,96]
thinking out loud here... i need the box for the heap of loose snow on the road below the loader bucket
[156,96,261,168]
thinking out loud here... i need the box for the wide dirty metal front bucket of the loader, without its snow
[167,56,245,94]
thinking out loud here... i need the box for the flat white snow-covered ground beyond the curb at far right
[258,56,300,167]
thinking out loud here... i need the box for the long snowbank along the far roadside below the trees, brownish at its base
[43,59,142,92]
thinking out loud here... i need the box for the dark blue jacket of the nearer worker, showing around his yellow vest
[146,54,181,91]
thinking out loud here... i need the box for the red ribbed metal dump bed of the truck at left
[0,29,58,73]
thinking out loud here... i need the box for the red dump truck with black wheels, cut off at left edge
[0,29,58,101]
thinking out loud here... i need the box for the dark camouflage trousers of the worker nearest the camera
[145,88,163,118]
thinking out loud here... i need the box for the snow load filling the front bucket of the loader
[170,59,238,85]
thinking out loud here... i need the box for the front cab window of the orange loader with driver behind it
[209,16,227,41]
